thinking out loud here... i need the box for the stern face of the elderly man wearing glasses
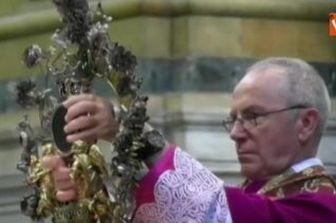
[230,69,299,179]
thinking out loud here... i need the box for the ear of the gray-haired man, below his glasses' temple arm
[298,108,321,143]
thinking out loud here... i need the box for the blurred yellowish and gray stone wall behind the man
[0,0,336,223]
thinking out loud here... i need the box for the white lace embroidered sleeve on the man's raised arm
[134,149,232,223]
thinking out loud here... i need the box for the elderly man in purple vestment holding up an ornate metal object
[46,58,336,223]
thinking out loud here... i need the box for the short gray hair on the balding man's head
[247,57,331,143]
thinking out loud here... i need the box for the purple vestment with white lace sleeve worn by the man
[133,146,336,223]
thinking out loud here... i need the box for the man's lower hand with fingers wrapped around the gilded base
[42,155,77,202]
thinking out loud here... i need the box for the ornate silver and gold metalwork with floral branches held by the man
[17,0,164,222]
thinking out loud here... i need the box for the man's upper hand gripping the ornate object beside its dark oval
[63,94,119,143]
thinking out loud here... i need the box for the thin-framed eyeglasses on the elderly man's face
[223,105,311,132]
